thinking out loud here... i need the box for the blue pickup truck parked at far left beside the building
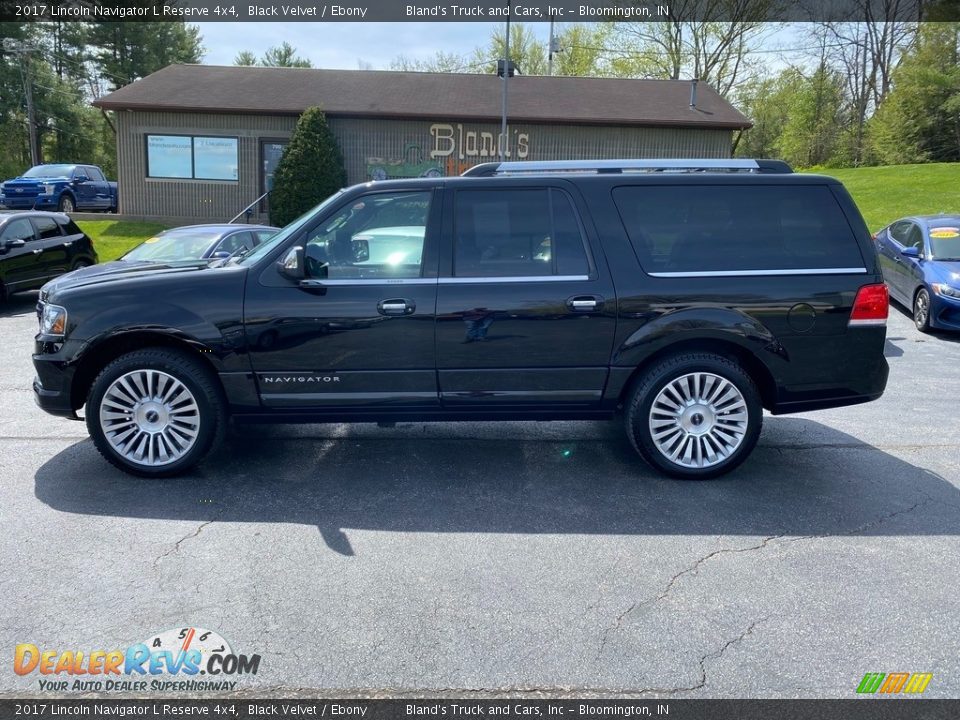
[0,163,117,213]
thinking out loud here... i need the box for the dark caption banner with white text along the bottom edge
[0,693,960,720]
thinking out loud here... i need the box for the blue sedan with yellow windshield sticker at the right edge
[875,215,960,332]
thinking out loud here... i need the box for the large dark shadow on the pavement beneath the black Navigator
[35,417,960,556]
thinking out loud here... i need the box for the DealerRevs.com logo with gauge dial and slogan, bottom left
[13,627,260,692]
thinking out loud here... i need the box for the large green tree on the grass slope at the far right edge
[867,23,960,164]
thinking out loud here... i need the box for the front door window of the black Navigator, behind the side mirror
[304,192,431,280]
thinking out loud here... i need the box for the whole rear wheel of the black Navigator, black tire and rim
[624,352,763,480]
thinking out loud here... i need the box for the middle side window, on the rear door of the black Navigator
[454,188,590,277]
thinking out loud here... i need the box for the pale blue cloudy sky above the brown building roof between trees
[197,22,510,70]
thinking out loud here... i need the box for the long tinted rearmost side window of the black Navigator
[613,185,864,273]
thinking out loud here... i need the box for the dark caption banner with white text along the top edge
[0,0,960,22]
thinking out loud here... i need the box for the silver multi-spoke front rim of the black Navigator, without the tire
[100,370,200,467]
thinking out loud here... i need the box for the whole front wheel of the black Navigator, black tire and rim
[86,348,227,477]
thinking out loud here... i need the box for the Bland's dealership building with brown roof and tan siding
[94,65,750,222]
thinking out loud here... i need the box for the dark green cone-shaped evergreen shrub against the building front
[270,107,347,226]
